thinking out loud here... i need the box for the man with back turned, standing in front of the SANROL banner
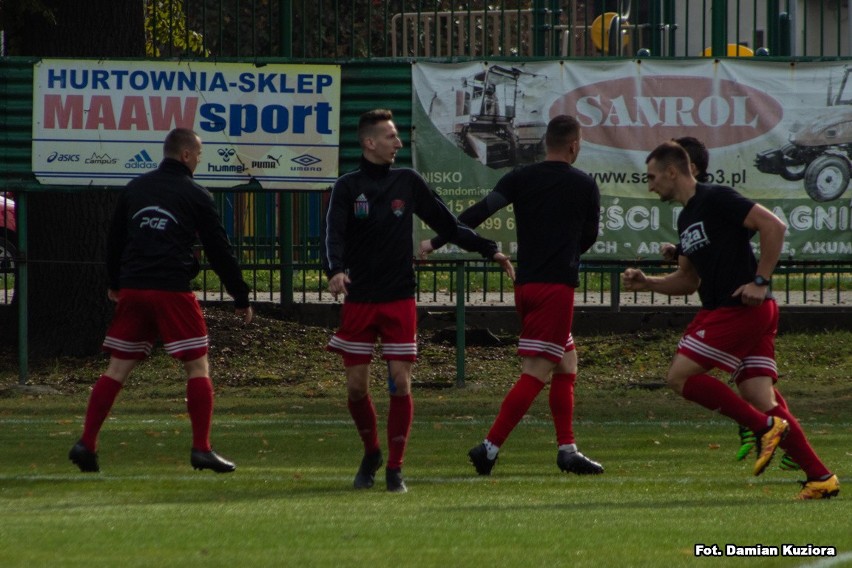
[420,115,603,475]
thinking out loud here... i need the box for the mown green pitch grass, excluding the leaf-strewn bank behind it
[0,390,852,567]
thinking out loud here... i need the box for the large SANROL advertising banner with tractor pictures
[412,59,852,260]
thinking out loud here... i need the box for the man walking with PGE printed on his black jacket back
[68,128,253,473]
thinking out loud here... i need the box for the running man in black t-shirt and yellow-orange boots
[623,142,840,499]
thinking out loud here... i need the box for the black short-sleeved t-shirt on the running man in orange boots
[677,183,757,310]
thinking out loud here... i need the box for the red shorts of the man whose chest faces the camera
[326,298,417,367]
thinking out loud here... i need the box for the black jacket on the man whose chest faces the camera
[325,157,497,302]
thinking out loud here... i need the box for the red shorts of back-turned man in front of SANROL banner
[515,283,574,363]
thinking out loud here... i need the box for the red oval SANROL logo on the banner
[550,75,784,151]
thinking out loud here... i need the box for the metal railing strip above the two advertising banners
[147,0,852,59]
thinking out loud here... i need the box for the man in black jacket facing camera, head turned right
[325,110,514,493]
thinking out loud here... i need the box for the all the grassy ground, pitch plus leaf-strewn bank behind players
[0,312,852,568]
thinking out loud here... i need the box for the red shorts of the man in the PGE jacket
[103,288,208,361]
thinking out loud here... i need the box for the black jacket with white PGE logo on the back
[107,158,249,308]
